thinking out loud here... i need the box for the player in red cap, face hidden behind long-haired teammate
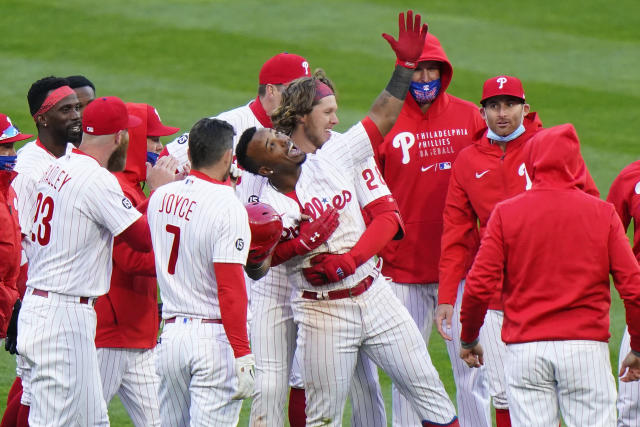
[160,52,311,171]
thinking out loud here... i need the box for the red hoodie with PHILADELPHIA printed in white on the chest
[376,33,485,283]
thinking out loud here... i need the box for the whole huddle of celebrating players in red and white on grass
[0,11,640,427]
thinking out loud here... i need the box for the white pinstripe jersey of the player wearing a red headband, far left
[11,140,73,247]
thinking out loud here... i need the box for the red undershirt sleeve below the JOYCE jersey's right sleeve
[213,262,251,358]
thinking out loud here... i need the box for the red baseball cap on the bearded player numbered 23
[82,96,142,135]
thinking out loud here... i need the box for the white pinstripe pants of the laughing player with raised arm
[293,277,455,426]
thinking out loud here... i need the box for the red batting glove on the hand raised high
[382,10,429,69]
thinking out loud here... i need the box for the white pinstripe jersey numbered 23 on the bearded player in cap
[27,149,141,297]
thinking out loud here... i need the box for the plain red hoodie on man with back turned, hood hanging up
[460,124,640,350]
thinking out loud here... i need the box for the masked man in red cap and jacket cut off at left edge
[0,114,33,427]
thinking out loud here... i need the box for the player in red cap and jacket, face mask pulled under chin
[435,76,598,426]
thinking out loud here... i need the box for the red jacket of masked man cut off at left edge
[0,171,22,338]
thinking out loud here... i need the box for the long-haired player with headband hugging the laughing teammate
[237,70,390,426]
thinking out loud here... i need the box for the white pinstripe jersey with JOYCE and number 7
[147,172,251,319]
